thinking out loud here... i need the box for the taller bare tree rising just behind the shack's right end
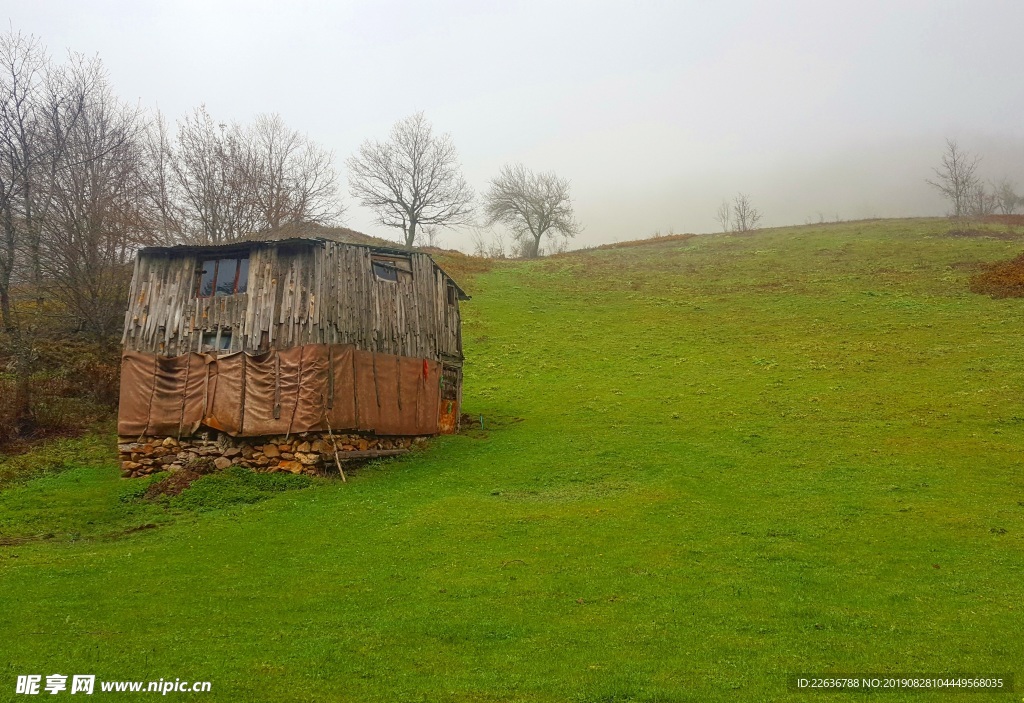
[347,113,474,247]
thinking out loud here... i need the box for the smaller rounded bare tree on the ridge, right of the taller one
[484,164,583,258]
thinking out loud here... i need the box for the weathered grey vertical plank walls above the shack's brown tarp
[123,241,462,363]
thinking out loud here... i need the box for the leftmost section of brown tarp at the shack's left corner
[118,352,211,437]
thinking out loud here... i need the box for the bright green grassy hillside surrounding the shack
[0,220,1024,703]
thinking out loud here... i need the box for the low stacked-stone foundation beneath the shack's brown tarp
[118,431,426,478]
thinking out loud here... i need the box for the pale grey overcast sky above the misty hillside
[3,0,1024,248]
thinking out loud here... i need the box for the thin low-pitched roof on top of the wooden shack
[138,222,470,300]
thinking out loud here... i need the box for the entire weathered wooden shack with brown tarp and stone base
[118,228,468,476]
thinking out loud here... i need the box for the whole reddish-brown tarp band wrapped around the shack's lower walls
[118,344,441,437]
